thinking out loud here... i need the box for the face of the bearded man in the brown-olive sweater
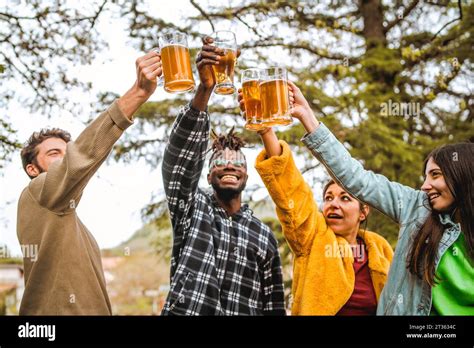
[26,138,67,177]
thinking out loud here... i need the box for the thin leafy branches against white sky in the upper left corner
[0,0,106,169]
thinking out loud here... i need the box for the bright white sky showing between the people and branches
[0,0,326,255]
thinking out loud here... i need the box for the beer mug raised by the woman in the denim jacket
[259,67,293,127]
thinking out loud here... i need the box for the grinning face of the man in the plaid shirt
[207,148,248,195]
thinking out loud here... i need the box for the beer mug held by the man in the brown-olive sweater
[158,32,195,93]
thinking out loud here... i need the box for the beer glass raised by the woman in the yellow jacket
[241,69,265,131]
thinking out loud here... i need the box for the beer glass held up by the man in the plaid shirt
[212,30,237,95]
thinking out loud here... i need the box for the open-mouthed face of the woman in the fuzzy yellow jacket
[323,183,369,237]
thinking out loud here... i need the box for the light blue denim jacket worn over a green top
[302,123,461,315]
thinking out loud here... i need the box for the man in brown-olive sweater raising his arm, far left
[17,52,162,315]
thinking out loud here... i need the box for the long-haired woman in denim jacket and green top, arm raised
[289,82,474,315]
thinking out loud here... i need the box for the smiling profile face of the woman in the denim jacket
[421,157,454,212]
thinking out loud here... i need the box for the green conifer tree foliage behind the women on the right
[113,1,474,253]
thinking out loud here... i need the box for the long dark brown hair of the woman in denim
[407,143,474,286]
